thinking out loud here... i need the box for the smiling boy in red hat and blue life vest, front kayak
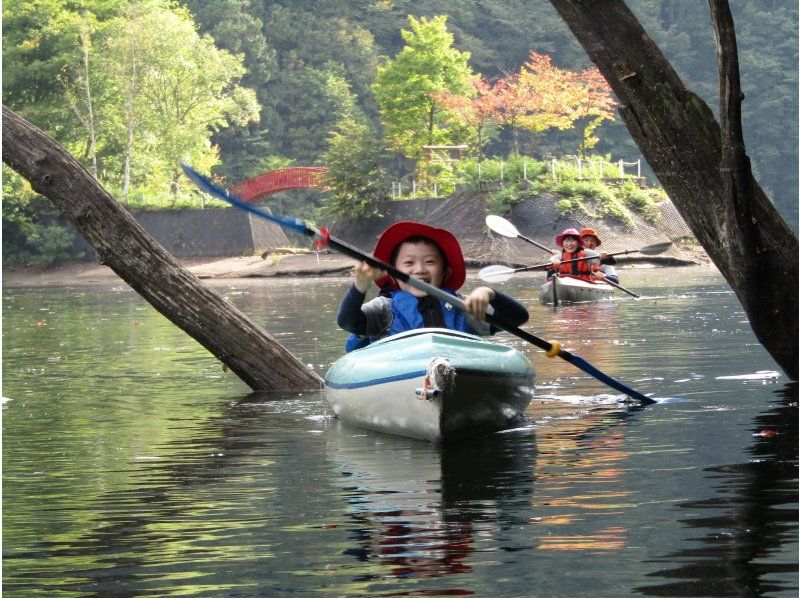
[337,222,528,351]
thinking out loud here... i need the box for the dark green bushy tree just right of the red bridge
[321,118,386,219]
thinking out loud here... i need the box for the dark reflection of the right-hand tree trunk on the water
[637,383,798,596]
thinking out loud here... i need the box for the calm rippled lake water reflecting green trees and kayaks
[2,268,798,596]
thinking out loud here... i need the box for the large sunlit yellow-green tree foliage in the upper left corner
[3,0,258,195]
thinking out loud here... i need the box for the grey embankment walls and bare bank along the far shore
[3,192,709,286]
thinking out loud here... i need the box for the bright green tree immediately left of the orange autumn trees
[372,16,474,159]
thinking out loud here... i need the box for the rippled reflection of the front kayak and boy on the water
[328,424,536,595]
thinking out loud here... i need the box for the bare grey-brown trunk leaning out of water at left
[3,106,322,390]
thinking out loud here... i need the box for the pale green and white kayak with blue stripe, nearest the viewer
[325,328,534,442]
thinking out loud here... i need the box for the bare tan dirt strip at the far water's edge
[2,249,709,287]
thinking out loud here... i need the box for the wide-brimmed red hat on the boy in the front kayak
[373,221,467,291]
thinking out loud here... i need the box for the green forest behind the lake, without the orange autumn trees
[3,0,798,262]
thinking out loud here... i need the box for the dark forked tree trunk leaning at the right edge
[550,0,798,380]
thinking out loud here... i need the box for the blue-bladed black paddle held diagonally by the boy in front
[186,164,656,405]
